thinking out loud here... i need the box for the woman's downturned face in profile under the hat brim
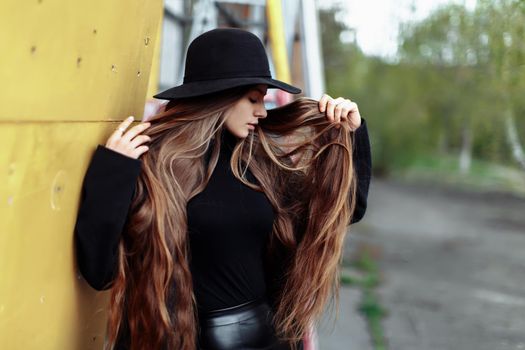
[224,84,268,138]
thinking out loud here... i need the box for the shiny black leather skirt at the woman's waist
[197,299,303,350]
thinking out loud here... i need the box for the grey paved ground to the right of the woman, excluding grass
[318,179,525,350]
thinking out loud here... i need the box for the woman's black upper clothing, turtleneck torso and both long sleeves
[75,119,371,310]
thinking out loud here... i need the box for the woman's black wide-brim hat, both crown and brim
[153,28,301,100]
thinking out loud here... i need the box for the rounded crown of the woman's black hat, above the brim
[184,28,271,83]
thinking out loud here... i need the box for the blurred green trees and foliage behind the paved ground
[320,0,525,180]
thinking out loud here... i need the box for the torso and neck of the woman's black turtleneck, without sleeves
[187,130,274,310]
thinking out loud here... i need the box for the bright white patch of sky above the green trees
[317,0,476,59]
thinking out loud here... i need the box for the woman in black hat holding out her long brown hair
[75,28,371,350]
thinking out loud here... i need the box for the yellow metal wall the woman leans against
[0,0,162,349]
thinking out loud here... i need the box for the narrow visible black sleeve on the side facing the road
[349,118,372,225]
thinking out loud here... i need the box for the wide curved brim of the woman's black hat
[153,77,302,100]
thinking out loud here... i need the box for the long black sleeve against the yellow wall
[75,145,142,290]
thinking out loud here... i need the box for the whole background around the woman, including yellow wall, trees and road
[0,0,525,350]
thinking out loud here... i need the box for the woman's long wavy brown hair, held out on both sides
[103,87,356,350]
